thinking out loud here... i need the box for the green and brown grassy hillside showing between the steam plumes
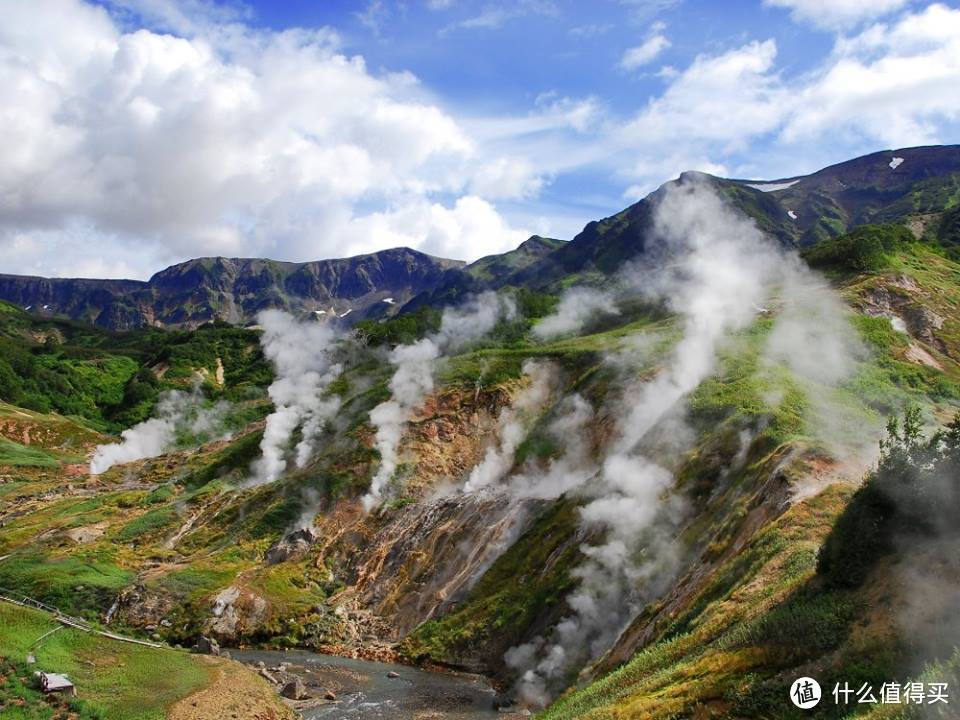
[0,221,960,718]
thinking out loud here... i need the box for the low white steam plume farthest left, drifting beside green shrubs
[90,387,229,475]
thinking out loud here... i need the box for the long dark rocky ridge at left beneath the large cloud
[0,248,463,330]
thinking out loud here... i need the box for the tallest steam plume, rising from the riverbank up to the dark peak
[506,180,785,706]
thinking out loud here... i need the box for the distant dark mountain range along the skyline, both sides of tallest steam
[0,145,960,330]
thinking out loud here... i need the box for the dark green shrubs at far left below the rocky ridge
[0,303,272,431]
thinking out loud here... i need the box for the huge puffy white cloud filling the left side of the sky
[0,0,543,276]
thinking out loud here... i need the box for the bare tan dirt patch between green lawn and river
[167,658,296,720]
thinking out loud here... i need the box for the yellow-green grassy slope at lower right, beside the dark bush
[538,487,856,720]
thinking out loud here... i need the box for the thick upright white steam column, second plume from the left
[248,310,343,485]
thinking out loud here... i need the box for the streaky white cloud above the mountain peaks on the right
[610,4,960,187]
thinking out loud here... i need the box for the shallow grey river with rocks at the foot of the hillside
[230,650,520,720]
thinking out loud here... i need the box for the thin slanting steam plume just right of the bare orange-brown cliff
[463,360,556,492]
